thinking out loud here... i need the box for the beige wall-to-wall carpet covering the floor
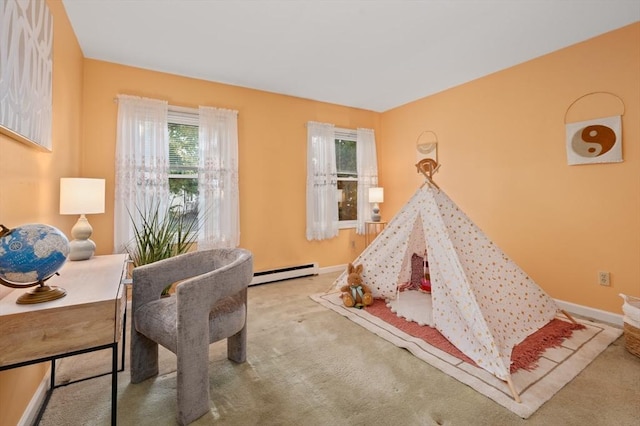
[41,274,640,426]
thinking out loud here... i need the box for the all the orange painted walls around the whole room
[0,0,640,425]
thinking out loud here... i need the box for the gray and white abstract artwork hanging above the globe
[0,0,53,151]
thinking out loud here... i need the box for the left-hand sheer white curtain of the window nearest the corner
[307,121,338,241]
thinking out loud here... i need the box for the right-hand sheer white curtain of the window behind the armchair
[198,106,240,250]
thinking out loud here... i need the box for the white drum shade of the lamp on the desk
[60,178,105,214]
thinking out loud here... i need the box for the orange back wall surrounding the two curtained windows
[82,60,379,271]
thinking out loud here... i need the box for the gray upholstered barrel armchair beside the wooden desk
[130,249,253,424]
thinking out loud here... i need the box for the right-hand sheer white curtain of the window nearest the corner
[356,129,378,234]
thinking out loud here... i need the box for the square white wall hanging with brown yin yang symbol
[565,115,622,166]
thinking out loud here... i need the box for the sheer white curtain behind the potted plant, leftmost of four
[114,95,169,253]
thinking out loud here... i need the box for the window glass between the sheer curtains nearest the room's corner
[335,129,358,228]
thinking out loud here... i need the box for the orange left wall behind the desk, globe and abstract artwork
[0,1,83,426]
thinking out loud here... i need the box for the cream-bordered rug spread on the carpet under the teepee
[311,292,622,419]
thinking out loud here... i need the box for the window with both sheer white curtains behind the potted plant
[114,95,240,253]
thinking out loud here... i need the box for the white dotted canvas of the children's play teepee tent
[335,168,559,388]
